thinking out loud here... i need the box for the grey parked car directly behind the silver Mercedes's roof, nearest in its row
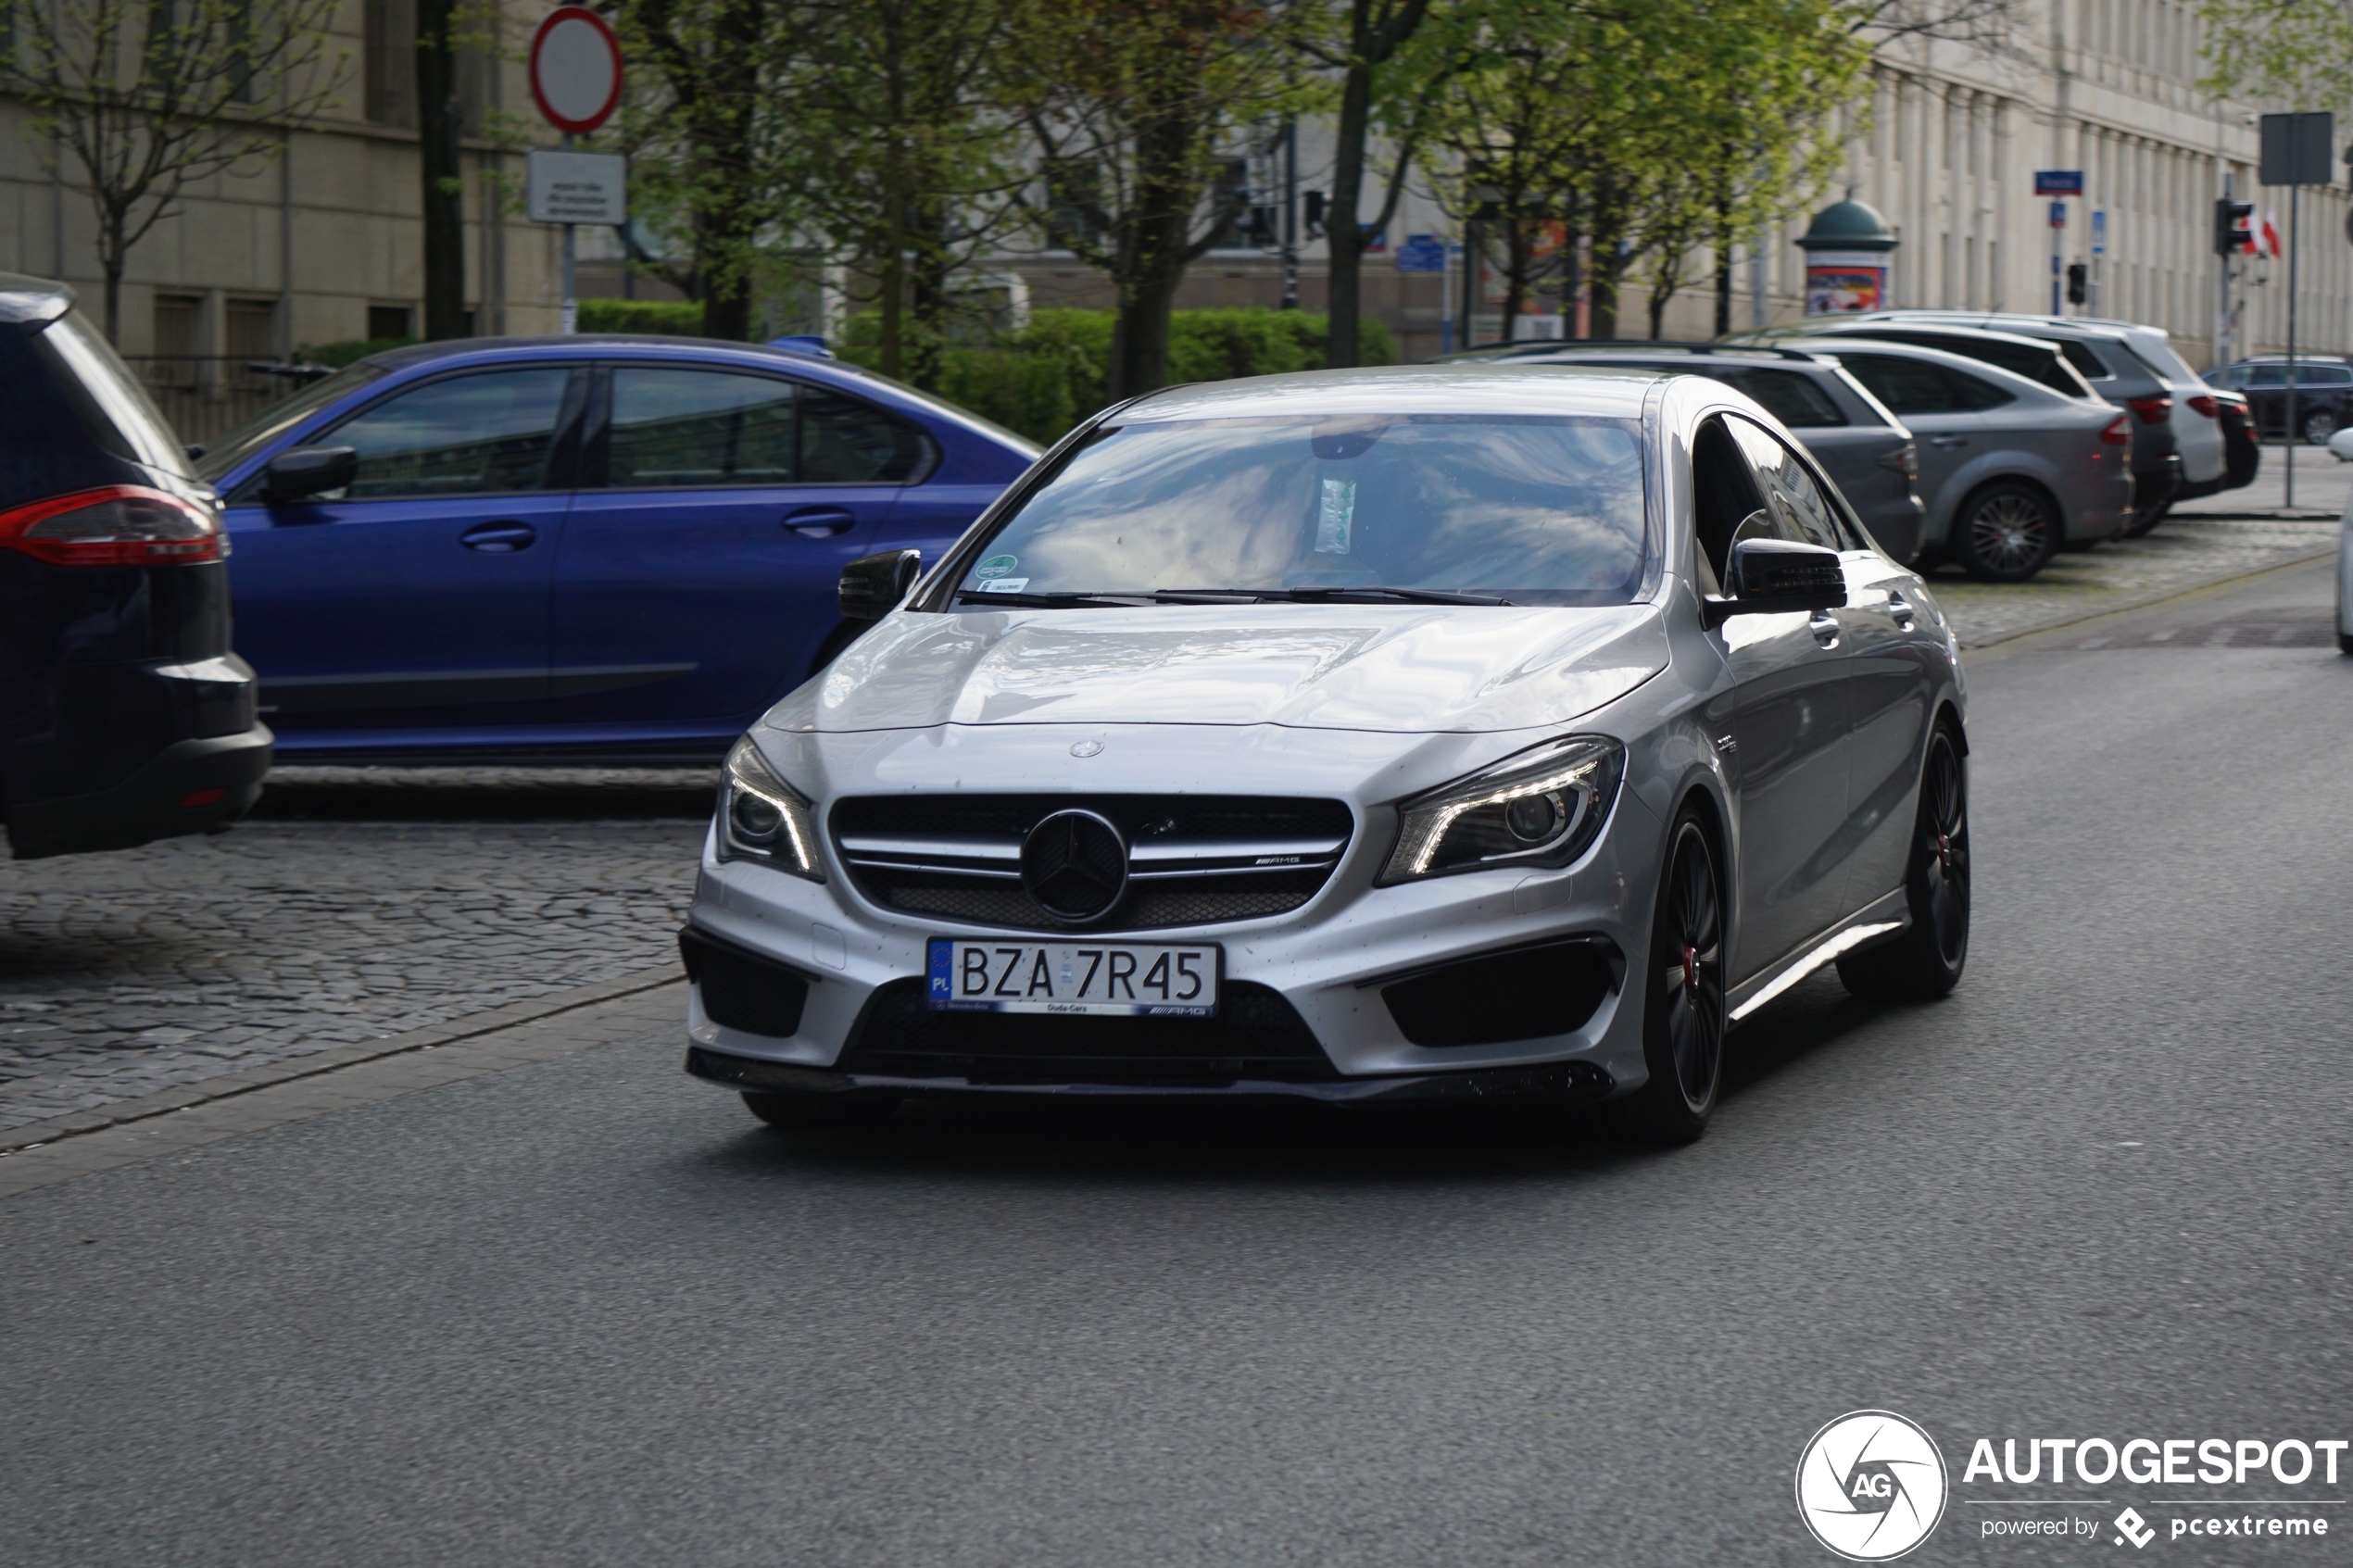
[1494,339,1925,562]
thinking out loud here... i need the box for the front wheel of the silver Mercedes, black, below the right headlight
[1629,807,1727,1145]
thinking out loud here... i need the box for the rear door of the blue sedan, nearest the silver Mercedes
[555,364,929,741]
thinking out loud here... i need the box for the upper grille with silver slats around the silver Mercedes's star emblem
[831,795,1355,931]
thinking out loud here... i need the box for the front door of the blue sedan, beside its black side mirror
[228,364,585,750]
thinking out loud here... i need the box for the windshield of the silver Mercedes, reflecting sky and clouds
[960,414,1650,604]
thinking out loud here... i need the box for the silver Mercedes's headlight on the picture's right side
[1378,735,1626,886]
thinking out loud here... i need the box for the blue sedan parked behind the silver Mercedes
[197,336,1038,759]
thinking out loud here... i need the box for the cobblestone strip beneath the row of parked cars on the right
[1930,517,2336,646]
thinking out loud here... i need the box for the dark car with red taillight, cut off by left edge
[0,272,271,860]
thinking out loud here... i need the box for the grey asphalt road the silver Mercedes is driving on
[0,569,2353,1568]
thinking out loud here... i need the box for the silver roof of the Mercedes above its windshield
[1108,359,1680,423]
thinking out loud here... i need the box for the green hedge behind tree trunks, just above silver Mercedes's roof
[836,310,1398,442]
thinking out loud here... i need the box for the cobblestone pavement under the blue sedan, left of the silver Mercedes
[0,769,715,1131]
